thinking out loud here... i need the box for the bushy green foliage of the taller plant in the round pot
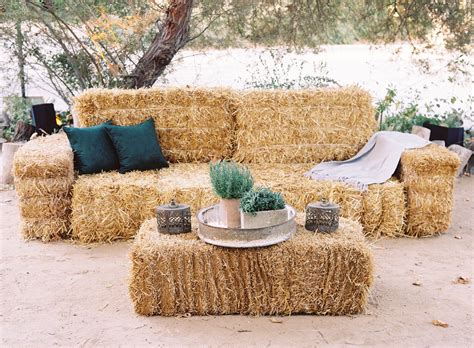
[209,161,253,199]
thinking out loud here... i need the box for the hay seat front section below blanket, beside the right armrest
[362,179,406,239]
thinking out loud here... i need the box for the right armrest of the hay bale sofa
[400,145,460,237]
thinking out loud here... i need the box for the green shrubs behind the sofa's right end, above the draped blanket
[375,88,469,133]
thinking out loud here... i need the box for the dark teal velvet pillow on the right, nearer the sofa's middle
[105,118,168,174]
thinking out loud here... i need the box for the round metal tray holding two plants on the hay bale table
[197,205,296,248]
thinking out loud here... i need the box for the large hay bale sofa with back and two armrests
[14,87,459,243]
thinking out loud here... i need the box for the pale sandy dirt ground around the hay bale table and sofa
[0,177,474,347]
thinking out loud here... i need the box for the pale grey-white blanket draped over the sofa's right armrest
[305,131,430,191]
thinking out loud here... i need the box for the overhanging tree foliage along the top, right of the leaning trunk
[191,0,472,51]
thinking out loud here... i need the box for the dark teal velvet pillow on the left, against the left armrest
[64,121,119,174]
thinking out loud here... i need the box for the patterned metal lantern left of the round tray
[156,199,191,234]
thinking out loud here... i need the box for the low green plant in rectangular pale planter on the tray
[240,187,288,228]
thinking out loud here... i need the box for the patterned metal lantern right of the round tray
[305,199,339,233]
